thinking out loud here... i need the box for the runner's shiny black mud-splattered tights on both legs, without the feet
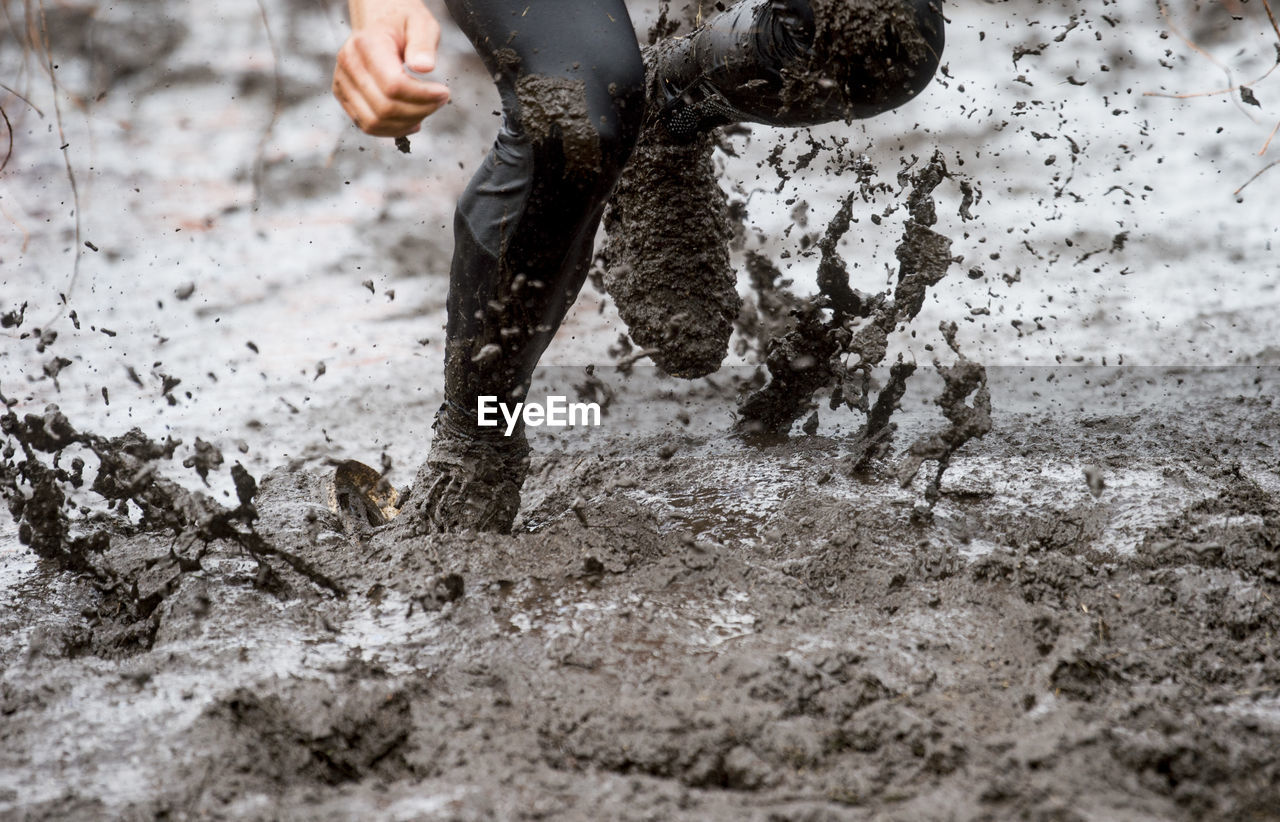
[445,0,942,419]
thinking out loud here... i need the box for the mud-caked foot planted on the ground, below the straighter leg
[402,403,530,534]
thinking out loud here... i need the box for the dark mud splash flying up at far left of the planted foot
[0,386,346,656]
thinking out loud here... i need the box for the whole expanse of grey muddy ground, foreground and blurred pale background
[0,0,1280,821]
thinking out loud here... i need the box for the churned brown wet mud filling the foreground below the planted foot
[0,369,1280,819]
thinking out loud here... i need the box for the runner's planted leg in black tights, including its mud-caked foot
[410,0,644,531]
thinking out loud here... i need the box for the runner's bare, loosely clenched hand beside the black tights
[333,0,449,137]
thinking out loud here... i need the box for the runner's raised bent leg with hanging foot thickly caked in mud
[602,3,945,378]
